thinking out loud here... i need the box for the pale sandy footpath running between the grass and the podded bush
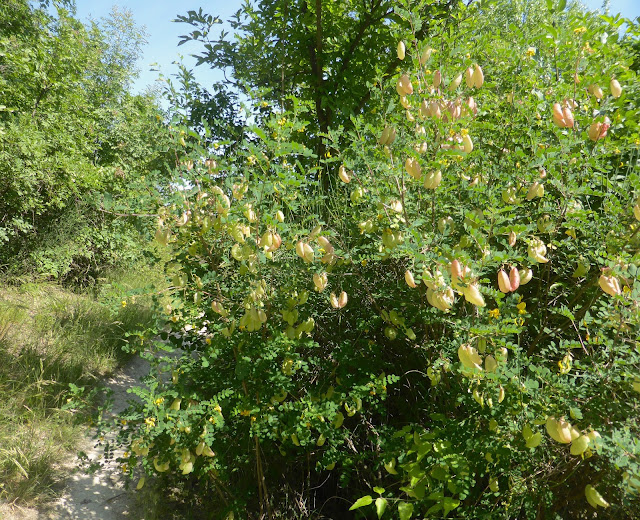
[0,357,149,520]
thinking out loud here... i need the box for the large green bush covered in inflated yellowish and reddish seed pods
[122,3,640,519]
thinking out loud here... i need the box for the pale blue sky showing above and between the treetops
[76,0,640,92]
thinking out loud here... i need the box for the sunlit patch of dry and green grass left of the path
[0,268,159,507]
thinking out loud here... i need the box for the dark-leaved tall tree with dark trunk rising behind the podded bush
[177,0,457,186]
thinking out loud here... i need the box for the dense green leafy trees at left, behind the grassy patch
[0,0,170,282]
